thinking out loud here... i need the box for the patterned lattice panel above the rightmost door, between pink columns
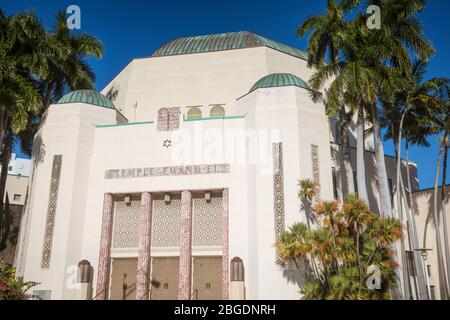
[192,197,223,246]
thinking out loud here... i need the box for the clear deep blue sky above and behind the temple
[0,0,450,188]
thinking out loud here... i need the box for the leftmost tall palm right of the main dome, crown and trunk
[297,0,357,193]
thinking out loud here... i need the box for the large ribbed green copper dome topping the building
[152,31,307,60]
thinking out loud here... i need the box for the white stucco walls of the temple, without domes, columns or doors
[16,31,416,299]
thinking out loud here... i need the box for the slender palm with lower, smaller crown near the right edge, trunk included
[383,60,439,299]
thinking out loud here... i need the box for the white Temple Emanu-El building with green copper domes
[16,32,430,300]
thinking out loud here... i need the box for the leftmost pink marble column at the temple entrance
[96,193,113,300]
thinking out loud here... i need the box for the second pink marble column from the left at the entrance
[136,192,152,300]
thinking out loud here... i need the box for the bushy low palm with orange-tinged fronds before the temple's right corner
[276,195,402,300]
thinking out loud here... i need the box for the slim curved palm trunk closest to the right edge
[433,136,448,300]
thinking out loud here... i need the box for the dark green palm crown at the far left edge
[0,10,49,152]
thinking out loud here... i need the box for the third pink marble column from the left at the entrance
[178,191,192,300]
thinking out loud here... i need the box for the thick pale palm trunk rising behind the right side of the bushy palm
[371,104,392,217]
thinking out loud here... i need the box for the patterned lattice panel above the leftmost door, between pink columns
[112,200,141,248]
